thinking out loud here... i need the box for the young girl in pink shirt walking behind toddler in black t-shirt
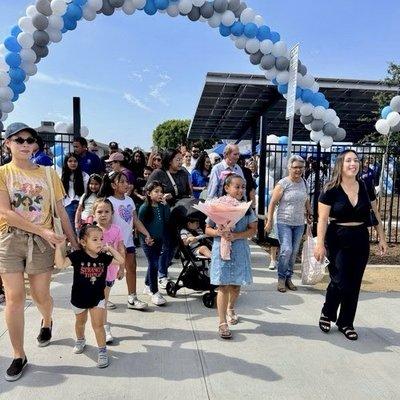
[93,199,125,344]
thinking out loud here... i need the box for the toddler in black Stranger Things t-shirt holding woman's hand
[55,224,124,368]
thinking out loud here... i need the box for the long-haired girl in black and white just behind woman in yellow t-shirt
[61,153,89,226]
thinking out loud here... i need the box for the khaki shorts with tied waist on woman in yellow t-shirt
[0,228,54,275]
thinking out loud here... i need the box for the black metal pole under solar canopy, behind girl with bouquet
[257,113,267,241]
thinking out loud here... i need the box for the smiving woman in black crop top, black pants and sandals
[314,150,387,340]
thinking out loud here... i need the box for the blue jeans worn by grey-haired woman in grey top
[277,223,304,279]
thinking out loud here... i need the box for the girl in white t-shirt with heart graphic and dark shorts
[99,172,153,310]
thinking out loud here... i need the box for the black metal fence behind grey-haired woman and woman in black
[260,144,400,243]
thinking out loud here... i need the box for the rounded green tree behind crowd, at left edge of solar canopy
[153,119,214,150]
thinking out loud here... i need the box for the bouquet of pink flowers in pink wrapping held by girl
[193,196,251,260]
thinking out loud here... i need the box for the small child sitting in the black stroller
[180,216,211,259]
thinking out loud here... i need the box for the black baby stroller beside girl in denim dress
[166,199,217,308]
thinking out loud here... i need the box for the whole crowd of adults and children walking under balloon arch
[0,123,386,381]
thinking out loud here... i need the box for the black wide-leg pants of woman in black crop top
[322,223,369,327]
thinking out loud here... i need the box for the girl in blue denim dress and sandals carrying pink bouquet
[206,174,257,339]
